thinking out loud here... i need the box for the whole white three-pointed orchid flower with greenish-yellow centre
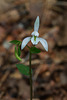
[21,16,48,51]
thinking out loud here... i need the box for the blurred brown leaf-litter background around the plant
[0,0,67,100]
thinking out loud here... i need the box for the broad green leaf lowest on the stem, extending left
[16,64,32,75]
